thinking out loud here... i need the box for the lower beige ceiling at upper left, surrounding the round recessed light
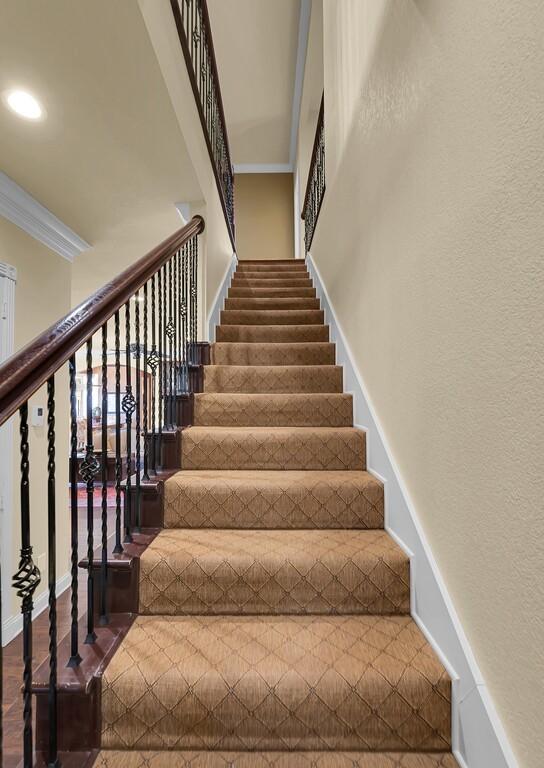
[0,0,201,299]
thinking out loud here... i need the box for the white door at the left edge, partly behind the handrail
[0,262,17,645]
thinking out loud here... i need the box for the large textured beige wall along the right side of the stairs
[302,0,544,768]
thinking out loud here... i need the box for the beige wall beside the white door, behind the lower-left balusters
[0,217,72,621]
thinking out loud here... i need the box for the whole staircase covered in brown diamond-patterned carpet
[96,261,456,768]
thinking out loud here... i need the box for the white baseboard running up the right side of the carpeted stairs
[307,254,518,768]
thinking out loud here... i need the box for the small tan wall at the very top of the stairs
[234,173,295,259]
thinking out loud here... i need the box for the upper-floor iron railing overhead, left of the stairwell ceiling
[170,0,235,248]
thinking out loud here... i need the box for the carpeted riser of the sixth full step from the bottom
[204,365,343,394]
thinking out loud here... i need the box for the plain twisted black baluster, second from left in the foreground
[47,376,60,768]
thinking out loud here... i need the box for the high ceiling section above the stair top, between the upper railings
[208,0,300,170]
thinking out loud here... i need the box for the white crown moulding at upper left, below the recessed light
[0,171,91,261]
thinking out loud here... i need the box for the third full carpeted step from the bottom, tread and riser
[164,469,383,528]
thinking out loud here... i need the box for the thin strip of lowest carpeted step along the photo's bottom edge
[94,750,458,768]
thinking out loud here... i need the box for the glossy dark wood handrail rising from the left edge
[0,216,204,425]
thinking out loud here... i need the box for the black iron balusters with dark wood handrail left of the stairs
[0,216,204,768]
